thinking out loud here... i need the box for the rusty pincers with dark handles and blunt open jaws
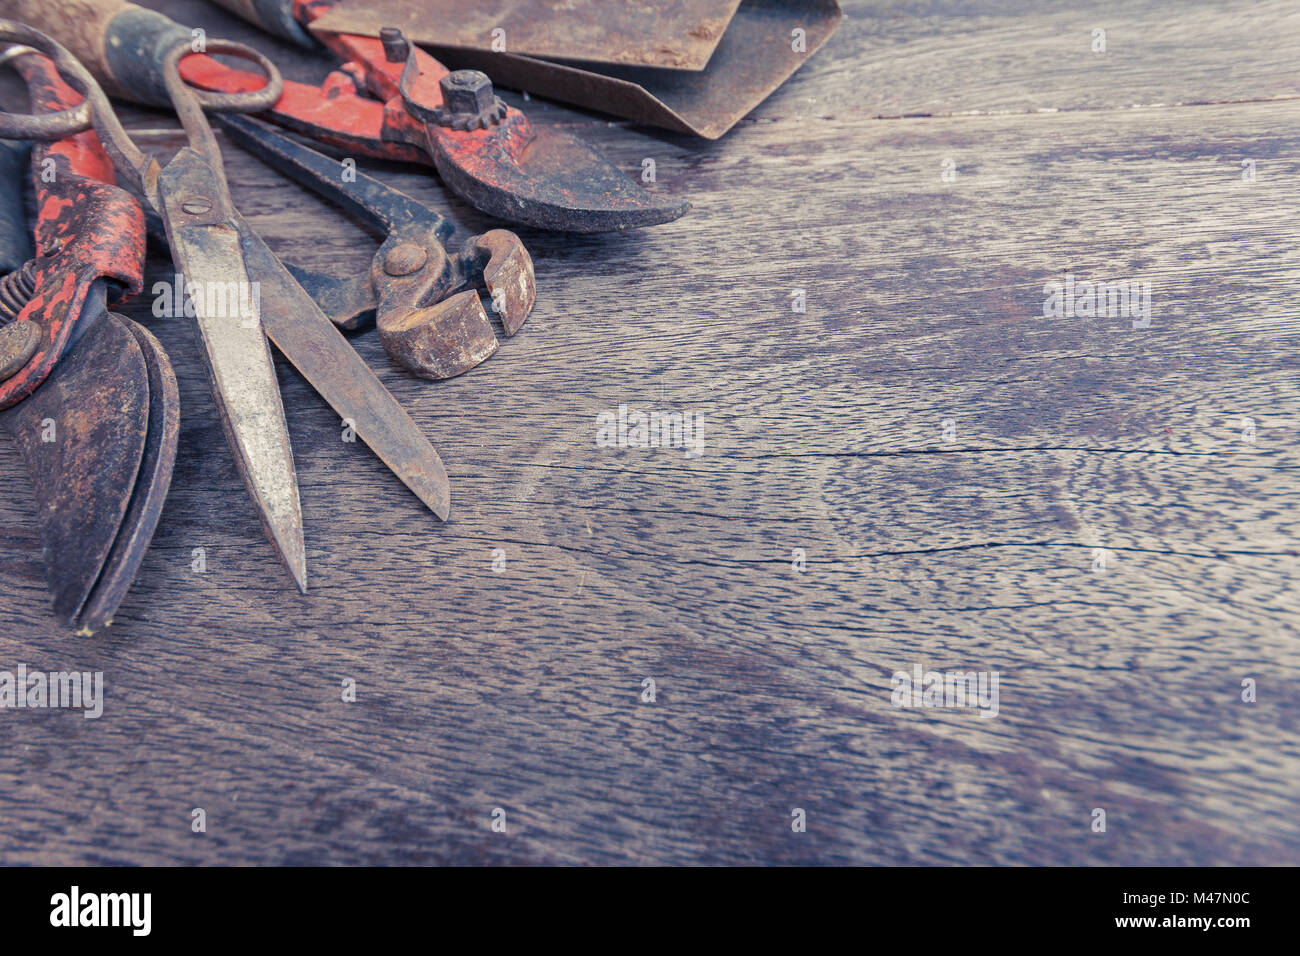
[218,116,537,380]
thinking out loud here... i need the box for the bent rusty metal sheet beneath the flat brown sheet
[311,0,842,139]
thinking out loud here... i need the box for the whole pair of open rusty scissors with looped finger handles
[0,18,449,591]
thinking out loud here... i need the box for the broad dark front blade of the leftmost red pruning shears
[0,312,150,624]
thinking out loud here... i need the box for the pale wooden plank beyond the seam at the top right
[780,0,1300,120]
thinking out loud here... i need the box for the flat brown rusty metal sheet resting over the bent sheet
[313,0,740,70]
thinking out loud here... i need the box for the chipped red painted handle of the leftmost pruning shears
[0,56,144,410]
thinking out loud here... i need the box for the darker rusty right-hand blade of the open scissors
[235,213,451,520]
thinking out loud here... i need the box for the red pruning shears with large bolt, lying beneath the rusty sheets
[184,0,689,233]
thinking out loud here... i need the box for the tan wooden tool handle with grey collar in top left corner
[0,0,191,105]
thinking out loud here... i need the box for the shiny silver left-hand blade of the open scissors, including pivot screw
[156,150,307,592]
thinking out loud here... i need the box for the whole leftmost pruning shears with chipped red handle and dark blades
[0,47,181,633]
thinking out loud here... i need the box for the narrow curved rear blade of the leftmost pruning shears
[78,312,181,633]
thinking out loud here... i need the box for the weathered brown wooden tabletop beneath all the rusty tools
[0,0,1300,864]
